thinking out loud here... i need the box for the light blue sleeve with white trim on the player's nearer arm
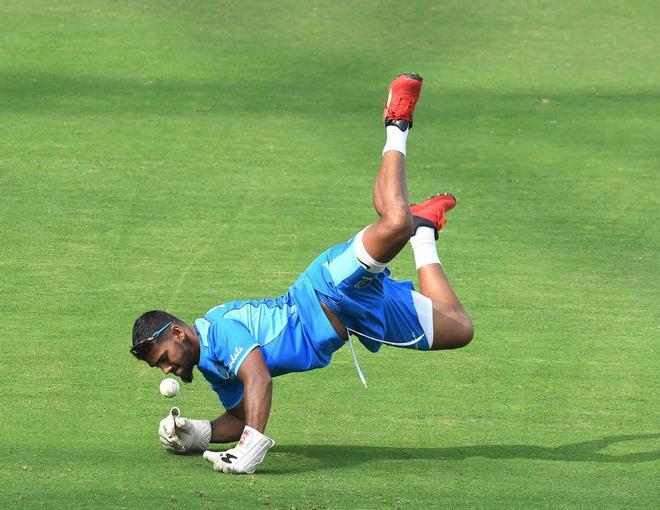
[211,319,259,376]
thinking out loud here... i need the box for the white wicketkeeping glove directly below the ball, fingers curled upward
[158,407,211,453]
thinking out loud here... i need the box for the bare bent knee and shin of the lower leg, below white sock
[417,264,474,350]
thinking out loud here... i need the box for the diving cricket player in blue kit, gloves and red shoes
[131,73,473,473]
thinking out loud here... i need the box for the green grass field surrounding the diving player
[0,0,660,509]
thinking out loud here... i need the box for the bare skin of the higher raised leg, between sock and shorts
[362,151,413,263]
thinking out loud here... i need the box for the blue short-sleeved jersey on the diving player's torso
[195,275,344,409]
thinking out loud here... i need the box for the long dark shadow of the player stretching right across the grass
[263,433,660,474]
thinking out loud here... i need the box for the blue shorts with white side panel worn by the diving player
[301,234,433,352]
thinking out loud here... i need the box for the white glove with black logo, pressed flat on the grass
[204,426,275,474]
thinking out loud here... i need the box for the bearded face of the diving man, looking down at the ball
[144,326,197,383]
